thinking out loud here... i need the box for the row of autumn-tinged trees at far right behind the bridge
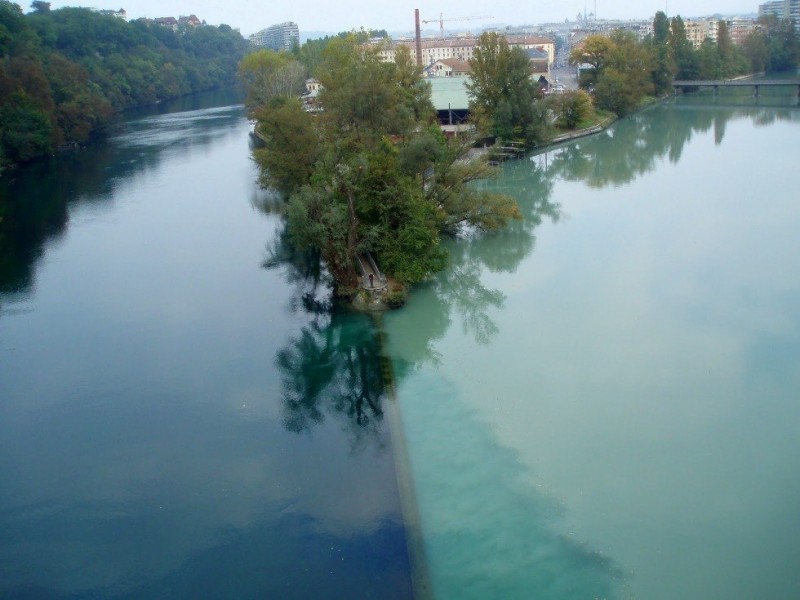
[570,12,800,115]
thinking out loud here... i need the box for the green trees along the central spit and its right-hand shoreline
[247,12,799,311]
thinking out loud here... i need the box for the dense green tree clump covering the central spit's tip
[240,37,519,293]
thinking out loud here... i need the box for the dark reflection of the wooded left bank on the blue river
[0,93,243,300]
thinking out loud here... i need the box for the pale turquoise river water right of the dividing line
[386,99,800,599]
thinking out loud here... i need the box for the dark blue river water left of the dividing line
[0,91,418,599]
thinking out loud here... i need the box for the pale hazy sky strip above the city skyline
[47,0,765,36]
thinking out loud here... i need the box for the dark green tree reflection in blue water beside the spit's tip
[263,218,386,448]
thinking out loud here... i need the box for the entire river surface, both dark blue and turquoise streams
[0,86,800,599]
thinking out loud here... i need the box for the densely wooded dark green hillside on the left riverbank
[0,0,247,168]
